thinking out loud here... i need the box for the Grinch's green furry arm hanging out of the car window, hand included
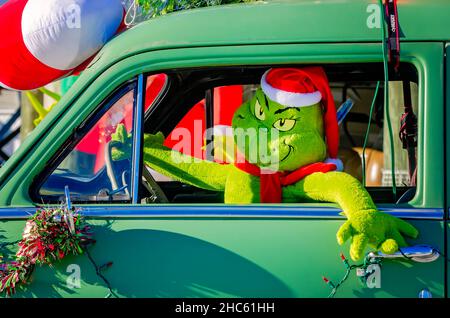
[287,172,418,260]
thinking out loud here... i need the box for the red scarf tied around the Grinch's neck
[234,160,336,203]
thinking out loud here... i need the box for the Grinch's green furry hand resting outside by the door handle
[337,210,419,261]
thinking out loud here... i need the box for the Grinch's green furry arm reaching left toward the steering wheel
[112,125,230,191]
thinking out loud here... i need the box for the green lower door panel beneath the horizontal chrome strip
[0,211,445,298]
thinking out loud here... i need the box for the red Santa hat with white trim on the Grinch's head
[261,66,343,171]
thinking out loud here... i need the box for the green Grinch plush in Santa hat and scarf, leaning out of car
[113,67,418,260]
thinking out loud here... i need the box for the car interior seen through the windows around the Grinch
[34,63,418,204]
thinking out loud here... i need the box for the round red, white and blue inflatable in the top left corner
[0,0,124,90]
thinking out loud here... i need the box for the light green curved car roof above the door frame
[92,0,450,71]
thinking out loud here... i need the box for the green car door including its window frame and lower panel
[0,43,445,297]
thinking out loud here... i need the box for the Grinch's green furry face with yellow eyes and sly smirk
[232,89,327,171]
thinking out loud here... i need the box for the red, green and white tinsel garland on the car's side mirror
[0,208,94,295]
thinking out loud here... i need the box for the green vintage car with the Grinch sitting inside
[0,0,450,298]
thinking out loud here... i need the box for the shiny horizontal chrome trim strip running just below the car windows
[0,204,444,220]
